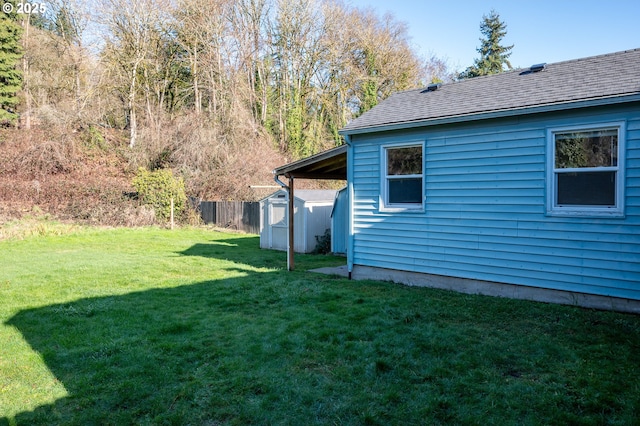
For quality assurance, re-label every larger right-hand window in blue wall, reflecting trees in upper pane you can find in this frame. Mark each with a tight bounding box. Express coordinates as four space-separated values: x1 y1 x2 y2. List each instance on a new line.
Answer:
548 123 624 216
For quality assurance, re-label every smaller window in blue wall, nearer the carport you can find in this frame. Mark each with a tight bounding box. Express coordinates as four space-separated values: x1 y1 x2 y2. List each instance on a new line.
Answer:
382 144 424 210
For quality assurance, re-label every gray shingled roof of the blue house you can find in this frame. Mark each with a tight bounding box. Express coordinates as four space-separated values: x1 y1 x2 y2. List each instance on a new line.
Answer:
340 49 640 134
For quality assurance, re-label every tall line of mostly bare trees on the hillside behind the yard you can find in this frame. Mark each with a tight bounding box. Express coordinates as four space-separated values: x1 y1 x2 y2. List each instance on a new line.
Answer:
0 0 504 201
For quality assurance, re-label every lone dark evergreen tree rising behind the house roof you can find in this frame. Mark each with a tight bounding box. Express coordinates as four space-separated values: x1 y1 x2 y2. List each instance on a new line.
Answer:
458 10 513 79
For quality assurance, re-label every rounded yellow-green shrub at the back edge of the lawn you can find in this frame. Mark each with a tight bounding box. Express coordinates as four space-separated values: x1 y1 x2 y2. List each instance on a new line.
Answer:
133 168 187 219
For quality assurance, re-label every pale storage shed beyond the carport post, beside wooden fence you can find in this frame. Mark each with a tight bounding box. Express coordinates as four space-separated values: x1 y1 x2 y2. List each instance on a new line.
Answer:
260 189 336 253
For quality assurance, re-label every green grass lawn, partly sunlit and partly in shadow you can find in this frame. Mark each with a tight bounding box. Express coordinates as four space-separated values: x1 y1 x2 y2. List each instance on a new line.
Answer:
0 229 640 425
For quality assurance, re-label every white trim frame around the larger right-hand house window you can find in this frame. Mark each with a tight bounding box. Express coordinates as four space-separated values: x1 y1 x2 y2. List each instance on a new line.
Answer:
546 121 626 217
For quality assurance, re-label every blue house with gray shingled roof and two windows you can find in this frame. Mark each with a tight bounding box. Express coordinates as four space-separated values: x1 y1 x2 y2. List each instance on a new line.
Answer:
338 49 640 312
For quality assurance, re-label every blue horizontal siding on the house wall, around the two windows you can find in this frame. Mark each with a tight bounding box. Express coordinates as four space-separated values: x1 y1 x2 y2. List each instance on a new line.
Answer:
353 108 640 299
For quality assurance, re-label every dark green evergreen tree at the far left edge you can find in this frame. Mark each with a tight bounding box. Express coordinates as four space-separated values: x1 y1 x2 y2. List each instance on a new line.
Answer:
0 6 22 123
